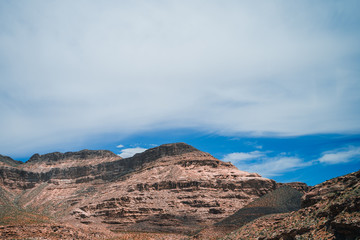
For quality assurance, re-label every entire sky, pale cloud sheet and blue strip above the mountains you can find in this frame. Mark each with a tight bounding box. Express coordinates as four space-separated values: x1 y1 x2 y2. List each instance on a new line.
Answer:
0 0 360 185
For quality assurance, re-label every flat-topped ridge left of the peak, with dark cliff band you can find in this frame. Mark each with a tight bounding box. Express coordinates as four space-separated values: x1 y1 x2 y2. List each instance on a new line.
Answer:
0 150 127 190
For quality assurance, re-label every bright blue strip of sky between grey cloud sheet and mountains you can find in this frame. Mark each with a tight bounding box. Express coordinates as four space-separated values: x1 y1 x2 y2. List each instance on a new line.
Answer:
0 133 360 186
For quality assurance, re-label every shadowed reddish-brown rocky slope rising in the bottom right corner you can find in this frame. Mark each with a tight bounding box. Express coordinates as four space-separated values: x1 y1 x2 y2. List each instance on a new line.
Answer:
223 171 360 240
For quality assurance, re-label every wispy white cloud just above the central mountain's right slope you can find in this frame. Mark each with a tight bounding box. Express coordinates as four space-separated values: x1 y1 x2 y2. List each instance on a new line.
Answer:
222 151 312 177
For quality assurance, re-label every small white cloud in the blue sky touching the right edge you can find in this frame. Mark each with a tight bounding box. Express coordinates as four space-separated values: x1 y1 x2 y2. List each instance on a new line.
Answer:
319 146 360 164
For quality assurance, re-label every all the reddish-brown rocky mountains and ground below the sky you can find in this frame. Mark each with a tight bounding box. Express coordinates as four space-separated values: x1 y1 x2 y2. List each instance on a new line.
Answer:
0 143 360 240
